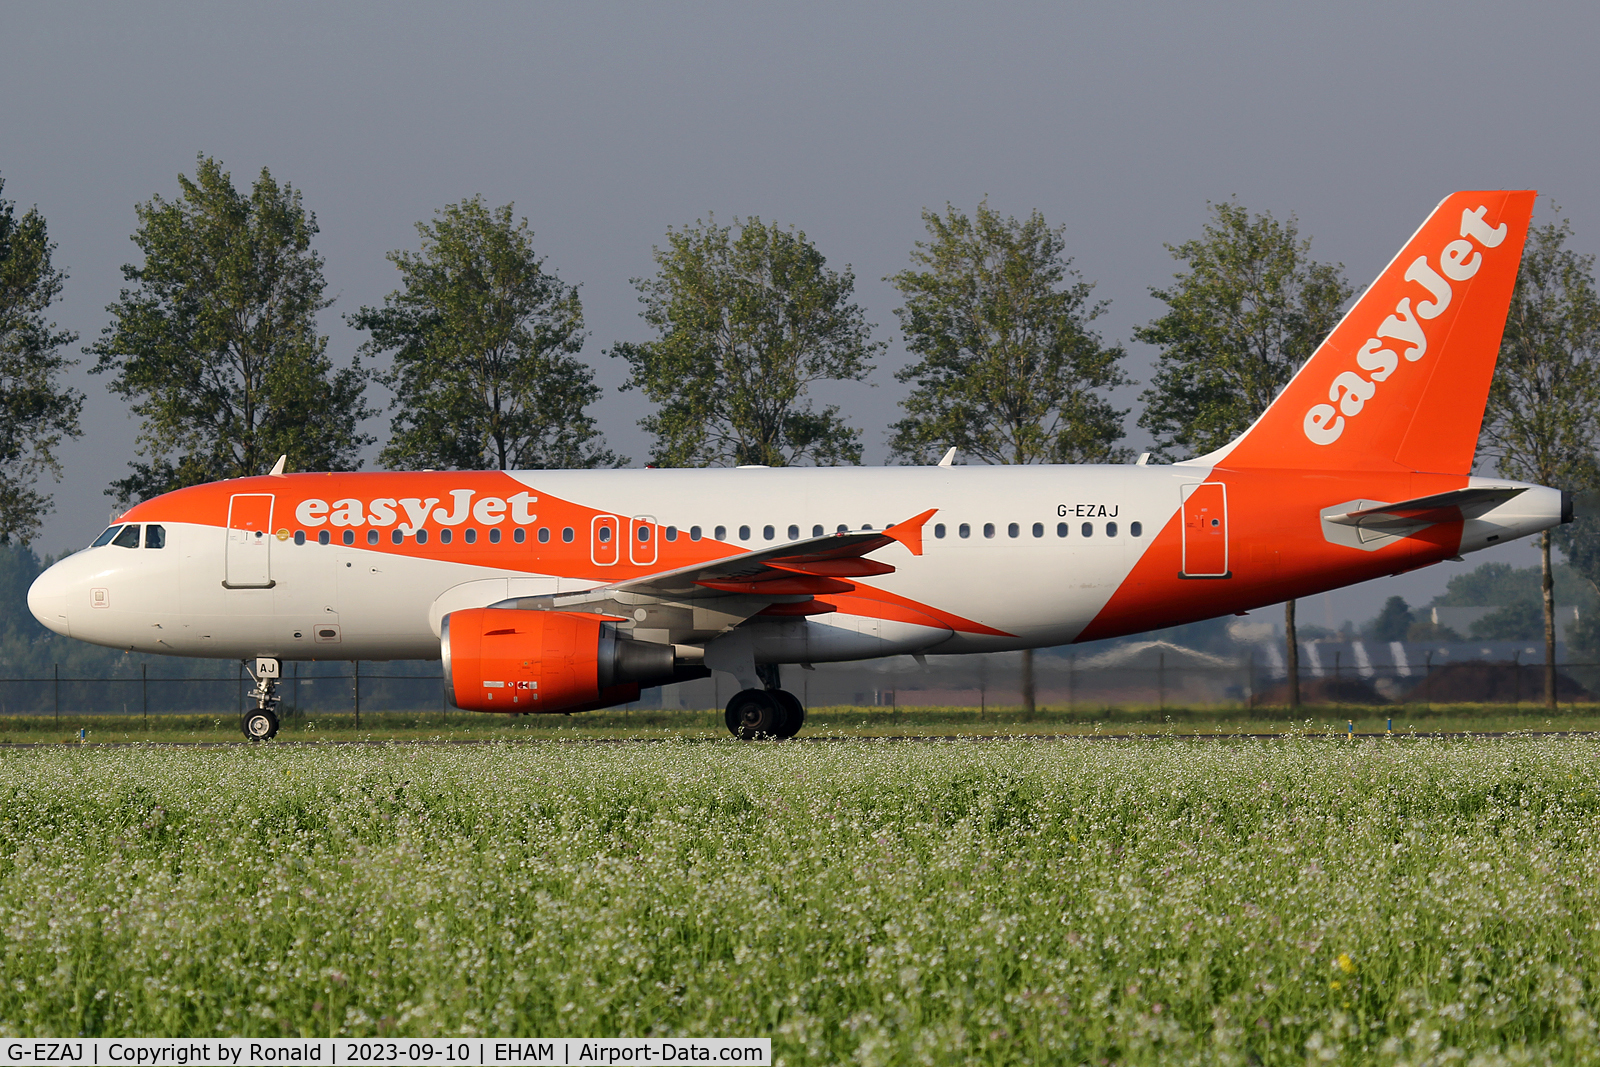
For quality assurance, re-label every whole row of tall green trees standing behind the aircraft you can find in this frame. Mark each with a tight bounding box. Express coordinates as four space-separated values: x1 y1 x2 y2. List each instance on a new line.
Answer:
0 155 1600 710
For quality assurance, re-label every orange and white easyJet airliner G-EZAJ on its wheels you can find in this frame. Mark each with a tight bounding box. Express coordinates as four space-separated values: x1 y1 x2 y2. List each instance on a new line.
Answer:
29 190 1571 739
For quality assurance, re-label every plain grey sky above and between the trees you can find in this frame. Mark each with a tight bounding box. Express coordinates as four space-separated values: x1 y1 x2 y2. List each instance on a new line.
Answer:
0 2 1600 622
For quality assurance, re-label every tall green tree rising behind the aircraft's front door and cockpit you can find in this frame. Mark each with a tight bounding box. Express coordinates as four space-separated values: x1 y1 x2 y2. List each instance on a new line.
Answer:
88 155 373 502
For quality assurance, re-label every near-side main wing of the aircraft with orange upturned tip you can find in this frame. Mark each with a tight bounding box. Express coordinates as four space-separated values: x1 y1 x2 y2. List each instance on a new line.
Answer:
493 509 938 643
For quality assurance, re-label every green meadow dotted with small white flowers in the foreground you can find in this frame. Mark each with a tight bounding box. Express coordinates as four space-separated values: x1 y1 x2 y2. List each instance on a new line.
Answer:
0 737 1600 1064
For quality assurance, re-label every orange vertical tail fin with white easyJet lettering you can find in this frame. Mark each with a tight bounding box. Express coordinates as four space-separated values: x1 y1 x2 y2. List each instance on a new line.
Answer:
1194 190 1534 474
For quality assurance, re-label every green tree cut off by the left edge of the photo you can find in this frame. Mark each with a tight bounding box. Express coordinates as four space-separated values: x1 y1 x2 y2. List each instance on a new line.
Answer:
0 179 83 544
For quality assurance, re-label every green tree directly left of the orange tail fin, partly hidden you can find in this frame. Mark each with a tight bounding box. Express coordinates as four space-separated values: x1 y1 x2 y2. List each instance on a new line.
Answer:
1133 203 1354 705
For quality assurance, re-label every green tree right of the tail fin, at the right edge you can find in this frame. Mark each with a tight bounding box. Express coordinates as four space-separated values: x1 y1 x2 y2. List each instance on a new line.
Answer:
1478 211 1600 710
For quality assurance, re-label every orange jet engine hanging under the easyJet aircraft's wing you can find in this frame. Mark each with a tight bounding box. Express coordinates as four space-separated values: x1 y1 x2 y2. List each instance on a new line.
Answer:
440 608 675 712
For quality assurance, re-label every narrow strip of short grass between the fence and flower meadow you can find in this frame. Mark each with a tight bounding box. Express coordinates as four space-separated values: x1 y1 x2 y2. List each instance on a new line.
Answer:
0 704 1600 745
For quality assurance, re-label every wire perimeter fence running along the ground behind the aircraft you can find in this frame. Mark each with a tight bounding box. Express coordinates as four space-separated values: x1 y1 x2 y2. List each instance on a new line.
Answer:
0 653 1600 720
